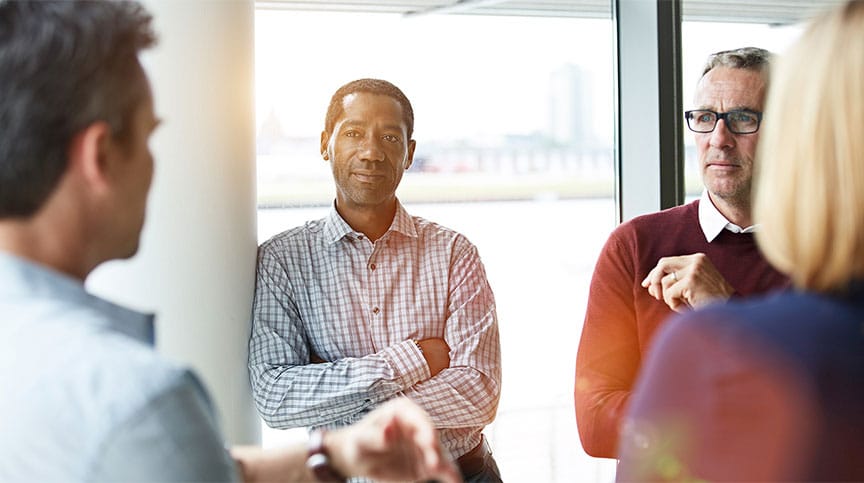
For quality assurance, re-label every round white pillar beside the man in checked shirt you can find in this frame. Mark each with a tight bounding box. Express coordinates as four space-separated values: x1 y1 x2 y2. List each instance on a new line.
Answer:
88 0 260 444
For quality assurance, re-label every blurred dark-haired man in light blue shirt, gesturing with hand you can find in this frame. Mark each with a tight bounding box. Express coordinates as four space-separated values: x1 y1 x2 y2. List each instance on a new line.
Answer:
0 1 458 482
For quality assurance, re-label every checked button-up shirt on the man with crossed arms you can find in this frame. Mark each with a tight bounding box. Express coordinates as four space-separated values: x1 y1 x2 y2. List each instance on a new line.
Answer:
249 200 501 457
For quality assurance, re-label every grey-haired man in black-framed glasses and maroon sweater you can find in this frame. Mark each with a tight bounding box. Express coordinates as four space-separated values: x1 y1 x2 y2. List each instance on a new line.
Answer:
574 47 788 458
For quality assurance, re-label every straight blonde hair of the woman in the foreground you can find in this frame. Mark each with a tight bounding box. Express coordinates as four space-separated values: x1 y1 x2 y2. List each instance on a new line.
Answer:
753 0 864 292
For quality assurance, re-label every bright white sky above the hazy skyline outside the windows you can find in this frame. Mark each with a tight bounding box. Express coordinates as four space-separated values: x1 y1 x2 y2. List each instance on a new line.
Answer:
255 10 800 144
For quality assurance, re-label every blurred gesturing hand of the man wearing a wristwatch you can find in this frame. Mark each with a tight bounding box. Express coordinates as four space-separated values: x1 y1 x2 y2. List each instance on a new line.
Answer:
324 398 462 483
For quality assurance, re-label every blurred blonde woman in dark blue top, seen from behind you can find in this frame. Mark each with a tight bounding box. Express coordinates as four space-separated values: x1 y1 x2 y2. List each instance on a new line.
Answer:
618 0 864 481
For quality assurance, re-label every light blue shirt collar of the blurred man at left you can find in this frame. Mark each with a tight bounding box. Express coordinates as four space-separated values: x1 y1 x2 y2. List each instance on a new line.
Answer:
0 252 155 346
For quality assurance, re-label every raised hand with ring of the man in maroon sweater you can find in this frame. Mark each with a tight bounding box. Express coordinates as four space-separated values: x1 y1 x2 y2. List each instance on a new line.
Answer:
642 253 735 312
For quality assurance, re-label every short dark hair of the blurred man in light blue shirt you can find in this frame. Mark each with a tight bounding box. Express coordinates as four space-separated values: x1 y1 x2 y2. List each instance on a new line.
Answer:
0 0 156 218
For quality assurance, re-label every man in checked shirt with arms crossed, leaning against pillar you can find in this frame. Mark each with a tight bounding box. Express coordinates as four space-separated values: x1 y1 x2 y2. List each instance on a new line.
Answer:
249 79 501 481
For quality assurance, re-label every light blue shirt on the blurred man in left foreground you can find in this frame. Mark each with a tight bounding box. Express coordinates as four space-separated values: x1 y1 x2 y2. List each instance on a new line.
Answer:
0 253 237 482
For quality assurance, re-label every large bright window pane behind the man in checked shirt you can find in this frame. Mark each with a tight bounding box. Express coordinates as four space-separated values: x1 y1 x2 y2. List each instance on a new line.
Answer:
256 6 615 482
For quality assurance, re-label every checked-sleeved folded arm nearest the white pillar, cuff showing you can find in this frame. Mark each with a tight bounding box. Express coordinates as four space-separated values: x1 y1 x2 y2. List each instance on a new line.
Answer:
249 253 429 428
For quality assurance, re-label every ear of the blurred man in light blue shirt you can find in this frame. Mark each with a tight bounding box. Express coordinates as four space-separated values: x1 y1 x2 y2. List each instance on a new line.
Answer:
67 121 111 194
